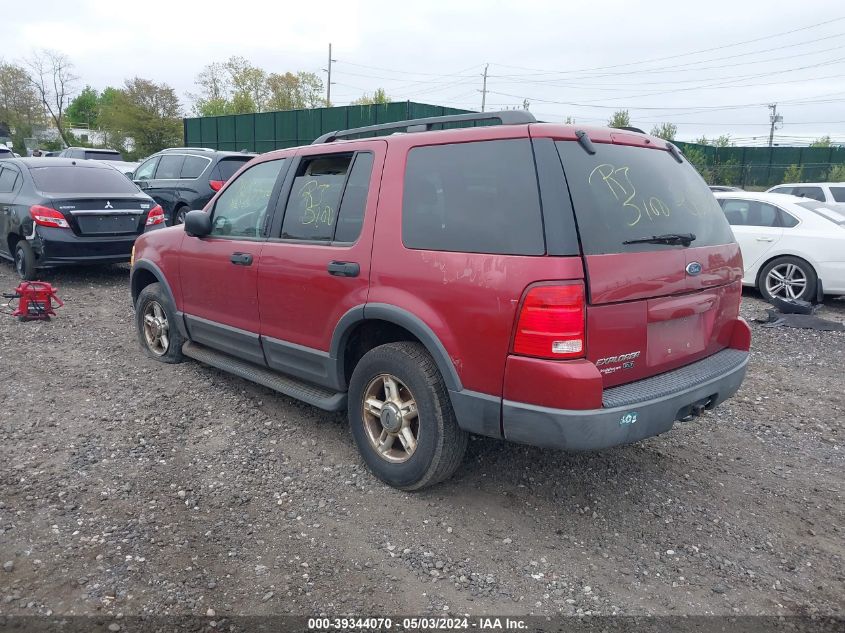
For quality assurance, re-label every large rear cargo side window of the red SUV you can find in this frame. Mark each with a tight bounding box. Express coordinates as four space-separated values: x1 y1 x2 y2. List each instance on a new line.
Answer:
402 139 545 255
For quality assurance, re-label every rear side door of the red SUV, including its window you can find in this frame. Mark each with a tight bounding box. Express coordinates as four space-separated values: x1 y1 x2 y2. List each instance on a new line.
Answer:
258 140 387 382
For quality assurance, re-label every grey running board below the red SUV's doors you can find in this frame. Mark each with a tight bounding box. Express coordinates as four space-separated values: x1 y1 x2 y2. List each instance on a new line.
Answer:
182 341 346 411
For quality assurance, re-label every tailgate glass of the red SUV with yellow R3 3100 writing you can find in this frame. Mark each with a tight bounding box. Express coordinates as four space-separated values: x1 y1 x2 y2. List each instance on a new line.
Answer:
557 141 734 255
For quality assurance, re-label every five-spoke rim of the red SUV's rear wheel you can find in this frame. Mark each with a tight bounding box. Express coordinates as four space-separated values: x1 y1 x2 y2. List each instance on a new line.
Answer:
362 374 420 464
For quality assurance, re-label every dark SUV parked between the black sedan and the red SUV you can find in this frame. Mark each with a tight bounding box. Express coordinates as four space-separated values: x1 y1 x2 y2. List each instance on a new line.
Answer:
132 147 255 225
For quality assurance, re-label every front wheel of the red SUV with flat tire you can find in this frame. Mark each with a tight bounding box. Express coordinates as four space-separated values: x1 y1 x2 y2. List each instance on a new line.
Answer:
135 283 185 363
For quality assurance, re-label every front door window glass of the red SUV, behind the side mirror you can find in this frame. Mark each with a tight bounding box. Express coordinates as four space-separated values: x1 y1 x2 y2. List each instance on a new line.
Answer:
211 158 287 237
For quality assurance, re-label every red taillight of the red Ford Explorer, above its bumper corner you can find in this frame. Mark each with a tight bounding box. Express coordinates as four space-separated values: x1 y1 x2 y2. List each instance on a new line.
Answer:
513 282 585 359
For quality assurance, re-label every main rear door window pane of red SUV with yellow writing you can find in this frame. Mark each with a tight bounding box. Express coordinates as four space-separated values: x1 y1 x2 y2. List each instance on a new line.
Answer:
282 154 353 242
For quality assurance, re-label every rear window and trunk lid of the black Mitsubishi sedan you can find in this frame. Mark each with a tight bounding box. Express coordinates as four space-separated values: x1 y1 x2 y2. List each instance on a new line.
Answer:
30 161 154 237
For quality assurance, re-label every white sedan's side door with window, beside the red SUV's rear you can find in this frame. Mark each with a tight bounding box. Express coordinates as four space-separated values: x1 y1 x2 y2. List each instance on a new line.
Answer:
719 198 783 273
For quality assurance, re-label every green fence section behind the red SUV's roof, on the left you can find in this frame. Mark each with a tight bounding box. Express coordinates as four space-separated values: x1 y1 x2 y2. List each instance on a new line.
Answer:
184 101 470 152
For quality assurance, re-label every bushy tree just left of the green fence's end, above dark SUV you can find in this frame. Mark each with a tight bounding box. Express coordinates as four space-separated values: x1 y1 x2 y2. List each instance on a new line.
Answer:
100 77 182 156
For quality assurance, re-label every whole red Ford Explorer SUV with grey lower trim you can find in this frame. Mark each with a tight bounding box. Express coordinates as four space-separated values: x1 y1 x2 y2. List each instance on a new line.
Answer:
131 112 750 490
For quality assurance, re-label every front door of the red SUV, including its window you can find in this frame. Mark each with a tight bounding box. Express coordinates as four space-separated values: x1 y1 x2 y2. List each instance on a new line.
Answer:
179 158 288 364
